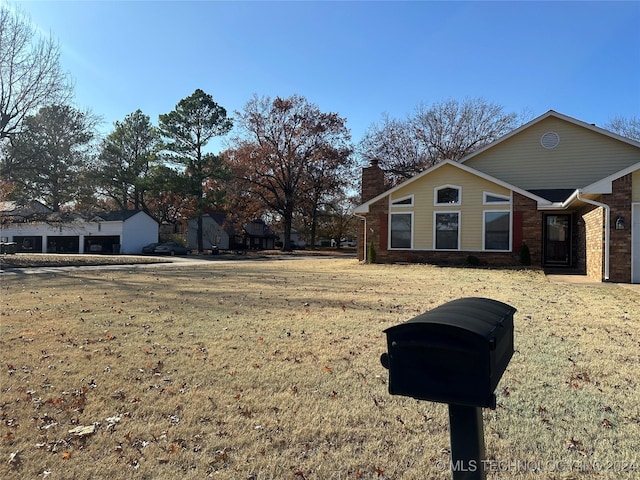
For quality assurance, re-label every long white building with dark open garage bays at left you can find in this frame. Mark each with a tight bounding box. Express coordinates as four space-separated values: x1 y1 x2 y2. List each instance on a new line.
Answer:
0 202 158 254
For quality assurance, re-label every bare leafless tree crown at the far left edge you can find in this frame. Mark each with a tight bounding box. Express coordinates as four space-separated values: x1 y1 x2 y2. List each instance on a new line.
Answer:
0 4 72 141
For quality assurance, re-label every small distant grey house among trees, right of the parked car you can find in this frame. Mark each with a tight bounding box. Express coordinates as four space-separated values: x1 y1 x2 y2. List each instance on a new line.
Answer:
187 213 276 250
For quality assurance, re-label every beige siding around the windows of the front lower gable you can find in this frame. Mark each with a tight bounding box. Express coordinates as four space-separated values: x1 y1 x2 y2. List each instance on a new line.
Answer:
390 165 511 251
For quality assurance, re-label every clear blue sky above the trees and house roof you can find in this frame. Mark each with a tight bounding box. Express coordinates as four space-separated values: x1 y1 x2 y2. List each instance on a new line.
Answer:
12 0 640 154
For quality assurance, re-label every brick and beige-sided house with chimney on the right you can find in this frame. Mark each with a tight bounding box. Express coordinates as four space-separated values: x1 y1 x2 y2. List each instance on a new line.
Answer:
355 110 640 283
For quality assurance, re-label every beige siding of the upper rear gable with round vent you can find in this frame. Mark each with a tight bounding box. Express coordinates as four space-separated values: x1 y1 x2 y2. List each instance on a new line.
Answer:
465 117 640 190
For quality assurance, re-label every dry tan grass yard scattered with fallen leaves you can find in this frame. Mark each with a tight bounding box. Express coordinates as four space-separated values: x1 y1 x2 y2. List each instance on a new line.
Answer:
0 258 640 480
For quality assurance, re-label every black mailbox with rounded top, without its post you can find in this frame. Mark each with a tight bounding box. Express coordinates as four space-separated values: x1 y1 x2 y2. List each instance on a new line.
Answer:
381 298 516 408
